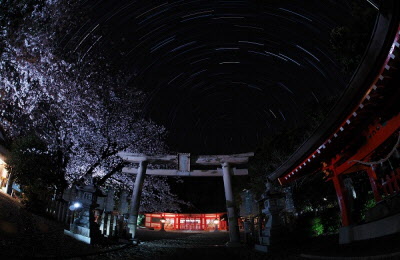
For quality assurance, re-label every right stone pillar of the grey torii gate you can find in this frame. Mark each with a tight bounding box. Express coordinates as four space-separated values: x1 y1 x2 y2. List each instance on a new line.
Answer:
222 162 240 246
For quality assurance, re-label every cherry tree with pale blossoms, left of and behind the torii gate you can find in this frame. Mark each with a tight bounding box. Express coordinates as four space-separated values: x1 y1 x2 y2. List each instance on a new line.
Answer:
0 0 188 210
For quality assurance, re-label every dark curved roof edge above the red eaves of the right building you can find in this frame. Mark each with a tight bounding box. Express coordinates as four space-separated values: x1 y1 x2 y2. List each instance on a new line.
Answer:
268 0 400 181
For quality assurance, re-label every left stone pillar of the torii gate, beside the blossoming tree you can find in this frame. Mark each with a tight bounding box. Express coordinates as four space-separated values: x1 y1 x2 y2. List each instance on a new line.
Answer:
128 161 147 239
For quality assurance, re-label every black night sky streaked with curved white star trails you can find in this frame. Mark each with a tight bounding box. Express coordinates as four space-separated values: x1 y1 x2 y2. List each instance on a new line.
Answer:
64 0 374 209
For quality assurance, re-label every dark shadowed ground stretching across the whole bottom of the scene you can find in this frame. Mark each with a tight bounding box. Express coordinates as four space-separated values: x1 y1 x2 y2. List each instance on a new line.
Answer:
0 193 400 260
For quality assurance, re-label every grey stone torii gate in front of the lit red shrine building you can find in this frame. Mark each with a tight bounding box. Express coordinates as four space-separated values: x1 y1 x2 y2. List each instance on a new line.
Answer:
118 152 254 246
